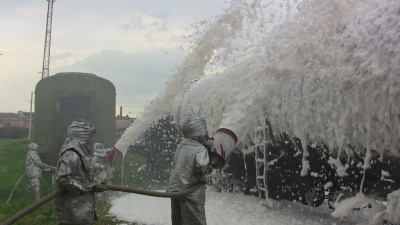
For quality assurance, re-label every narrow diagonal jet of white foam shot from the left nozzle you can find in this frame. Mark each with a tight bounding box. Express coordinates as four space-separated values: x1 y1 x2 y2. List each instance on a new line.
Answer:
115 1 272 154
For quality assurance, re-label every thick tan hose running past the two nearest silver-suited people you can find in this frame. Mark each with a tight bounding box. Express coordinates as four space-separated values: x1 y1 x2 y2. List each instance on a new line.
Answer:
1 183 202 225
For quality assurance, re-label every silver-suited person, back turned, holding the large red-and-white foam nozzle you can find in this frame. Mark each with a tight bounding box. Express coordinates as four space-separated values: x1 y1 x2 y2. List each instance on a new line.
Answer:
167 117 211 225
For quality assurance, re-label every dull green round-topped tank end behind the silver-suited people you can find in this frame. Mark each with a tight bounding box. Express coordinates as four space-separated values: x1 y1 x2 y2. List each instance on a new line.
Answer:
33 72 116 165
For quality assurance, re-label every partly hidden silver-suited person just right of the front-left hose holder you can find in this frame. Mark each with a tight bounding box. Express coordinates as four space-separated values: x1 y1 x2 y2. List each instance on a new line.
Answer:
93 143 113 184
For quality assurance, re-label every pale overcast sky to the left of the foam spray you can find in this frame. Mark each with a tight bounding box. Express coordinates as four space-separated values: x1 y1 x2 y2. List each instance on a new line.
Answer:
0 0 225 117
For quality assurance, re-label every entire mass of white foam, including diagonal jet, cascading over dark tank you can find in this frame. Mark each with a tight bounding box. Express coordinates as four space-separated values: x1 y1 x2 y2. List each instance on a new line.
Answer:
116 0 400 220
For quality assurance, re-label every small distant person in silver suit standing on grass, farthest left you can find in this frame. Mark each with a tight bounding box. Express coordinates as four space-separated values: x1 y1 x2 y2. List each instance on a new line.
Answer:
25 143 51 201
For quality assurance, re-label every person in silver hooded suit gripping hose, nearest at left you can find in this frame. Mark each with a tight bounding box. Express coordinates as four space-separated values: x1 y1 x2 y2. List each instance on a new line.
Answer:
54 120 95 224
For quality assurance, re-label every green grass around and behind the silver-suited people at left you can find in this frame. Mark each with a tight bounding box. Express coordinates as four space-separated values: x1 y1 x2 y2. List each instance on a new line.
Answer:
0 139 161 225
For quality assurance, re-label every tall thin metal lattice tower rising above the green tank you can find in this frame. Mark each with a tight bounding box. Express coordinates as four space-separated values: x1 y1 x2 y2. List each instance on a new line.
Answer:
42 0 56 79
